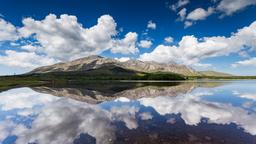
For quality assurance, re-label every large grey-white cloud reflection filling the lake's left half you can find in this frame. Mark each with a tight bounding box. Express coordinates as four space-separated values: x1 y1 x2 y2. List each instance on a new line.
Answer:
0 88 141 144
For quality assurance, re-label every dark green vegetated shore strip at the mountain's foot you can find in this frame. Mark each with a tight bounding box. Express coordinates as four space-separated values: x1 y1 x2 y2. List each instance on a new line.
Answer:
0 69 185 91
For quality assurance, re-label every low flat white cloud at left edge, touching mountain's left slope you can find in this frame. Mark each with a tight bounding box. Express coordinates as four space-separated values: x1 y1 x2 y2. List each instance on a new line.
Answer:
0 50 59 69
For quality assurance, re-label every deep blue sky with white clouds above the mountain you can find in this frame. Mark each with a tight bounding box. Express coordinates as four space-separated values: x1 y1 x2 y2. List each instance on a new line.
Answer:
0 0 256 75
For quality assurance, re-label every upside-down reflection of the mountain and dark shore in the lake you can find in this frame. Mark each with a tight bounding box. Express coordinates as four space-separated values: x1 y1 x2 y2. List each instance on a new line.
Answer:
32 82 224 104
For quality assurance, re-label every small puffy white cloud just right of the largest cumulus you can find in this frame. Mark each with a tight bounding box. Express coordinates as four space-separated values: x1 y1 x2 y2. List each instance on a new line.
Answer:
111 32 139 54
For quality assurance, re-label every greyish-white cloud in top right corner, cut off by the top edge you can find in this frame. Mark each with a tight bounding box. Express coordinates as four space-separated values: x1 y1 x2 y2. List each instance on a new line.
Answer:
217 0 256 15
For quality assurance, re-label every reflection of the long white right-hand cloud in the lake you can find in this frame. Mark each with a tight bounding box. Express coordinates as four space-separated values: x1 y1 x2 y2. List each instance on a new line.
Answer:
138 92 256 135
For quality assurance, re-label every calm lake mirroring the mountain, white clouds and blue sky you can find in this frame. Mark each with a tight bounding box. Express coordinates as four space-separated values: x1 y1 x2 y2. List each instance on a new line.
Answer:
0 80 256 144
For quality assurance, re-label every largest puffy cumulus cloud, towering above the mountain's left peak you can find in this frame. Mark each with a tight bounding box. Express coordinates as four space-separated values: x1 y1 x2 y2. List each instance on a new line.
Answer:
19 14 117 60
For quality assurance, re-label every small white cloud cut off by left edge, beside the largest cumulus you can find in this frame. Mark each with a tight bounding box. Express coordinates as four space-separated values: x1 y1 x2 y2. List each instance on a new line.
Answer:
0 18 18 41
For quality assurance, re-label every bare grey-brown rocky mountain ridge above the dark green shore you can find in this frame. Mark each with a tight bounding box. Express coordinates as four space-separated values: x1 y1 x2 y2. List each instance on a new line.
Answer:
29 55 199 76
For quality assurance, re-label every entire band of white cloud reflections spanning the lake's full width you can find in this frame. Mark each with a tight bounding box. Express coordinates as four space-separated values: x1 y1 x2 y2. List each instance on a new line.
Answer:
0 81 256 144
